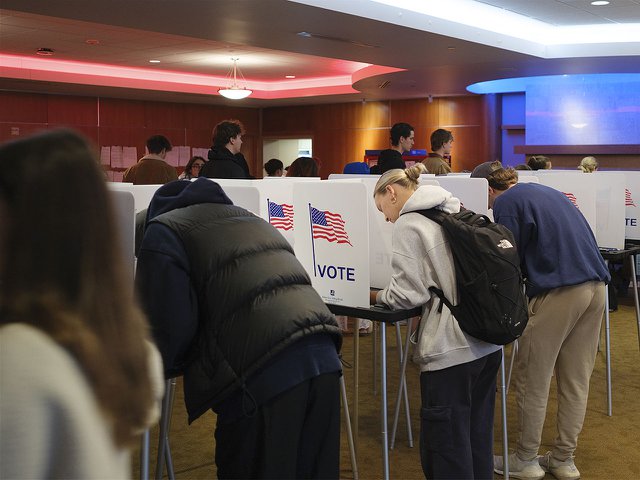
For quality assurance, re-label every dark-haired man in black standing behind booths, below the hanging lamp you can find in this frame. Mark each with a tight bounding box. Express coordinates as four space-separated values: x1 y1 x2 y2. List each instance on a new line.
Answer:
200 120 254 178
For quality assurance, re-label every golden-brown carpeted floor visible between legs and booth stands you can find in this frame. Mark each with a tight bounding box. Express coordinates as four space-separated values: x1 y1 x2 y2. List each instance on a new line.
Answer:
133 301 640 480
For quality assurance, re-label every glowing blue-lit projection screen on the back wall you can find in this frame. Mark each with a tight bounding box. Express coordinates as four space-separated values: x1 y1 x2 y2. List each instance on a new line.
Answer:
526 78 640 145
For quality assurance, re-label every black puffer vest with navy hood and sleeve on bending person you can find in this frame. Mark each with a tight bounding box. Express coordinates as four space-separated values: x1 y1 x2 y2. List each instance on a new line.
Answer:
137 179 341 421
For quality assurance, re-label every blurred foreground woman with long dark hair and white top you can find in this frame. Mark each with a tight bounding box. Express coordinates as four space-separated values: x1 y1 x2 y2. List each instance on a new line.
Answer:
0 130 162 478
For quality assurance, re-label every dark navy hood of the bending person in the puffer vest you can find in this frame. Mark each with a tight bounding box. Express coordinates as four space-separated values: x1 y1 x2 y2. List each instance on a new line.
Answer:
147 178 233 222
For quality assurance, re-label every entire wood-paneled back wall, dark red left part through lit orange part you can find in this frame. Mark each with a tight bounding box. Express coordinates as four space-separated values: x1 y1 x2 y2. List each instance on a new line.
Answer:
0 92 490 178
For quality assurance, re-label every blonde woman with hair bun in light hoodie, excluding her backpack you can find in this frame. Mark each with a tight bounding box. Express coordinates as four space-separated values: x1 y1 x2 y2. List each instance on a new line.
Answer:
371 164 502 479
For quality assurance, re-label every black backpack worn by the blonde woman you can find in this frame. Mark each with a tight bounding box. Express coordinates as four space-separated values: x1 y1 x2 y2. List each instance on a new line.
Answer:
408 209 529 345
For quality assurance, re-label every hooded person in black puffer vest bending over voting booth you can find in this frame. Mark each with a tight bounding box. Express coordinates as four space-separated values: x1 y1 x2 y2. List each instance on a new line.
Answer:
136 178 342 478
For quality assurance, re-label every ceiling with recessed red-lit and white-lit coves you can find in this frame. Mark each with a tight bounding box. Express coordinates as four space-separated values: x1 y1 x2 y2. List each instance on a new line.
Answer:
0 0 640 107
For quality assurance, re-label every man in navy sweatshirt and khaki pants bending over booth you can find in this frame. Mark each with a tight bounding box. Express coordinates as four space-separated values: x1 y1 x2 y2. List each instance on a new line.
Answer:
472 162 610 480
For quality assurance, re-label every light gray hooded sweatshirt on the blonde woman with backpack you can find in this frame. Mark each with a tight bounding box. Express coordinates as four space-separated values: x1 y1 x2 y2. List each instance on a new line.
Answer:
377 185 500 372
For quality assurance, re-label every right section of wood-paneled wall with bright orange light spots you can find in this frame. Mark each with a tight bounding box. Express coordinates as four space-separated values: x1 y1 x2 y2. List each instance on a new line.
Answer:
262 96 491 177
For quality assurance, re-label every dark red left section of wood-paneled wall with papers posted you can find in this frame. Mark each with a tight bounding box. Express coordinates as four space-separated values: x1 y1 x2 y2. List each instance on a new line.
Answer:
0 92 262 176
